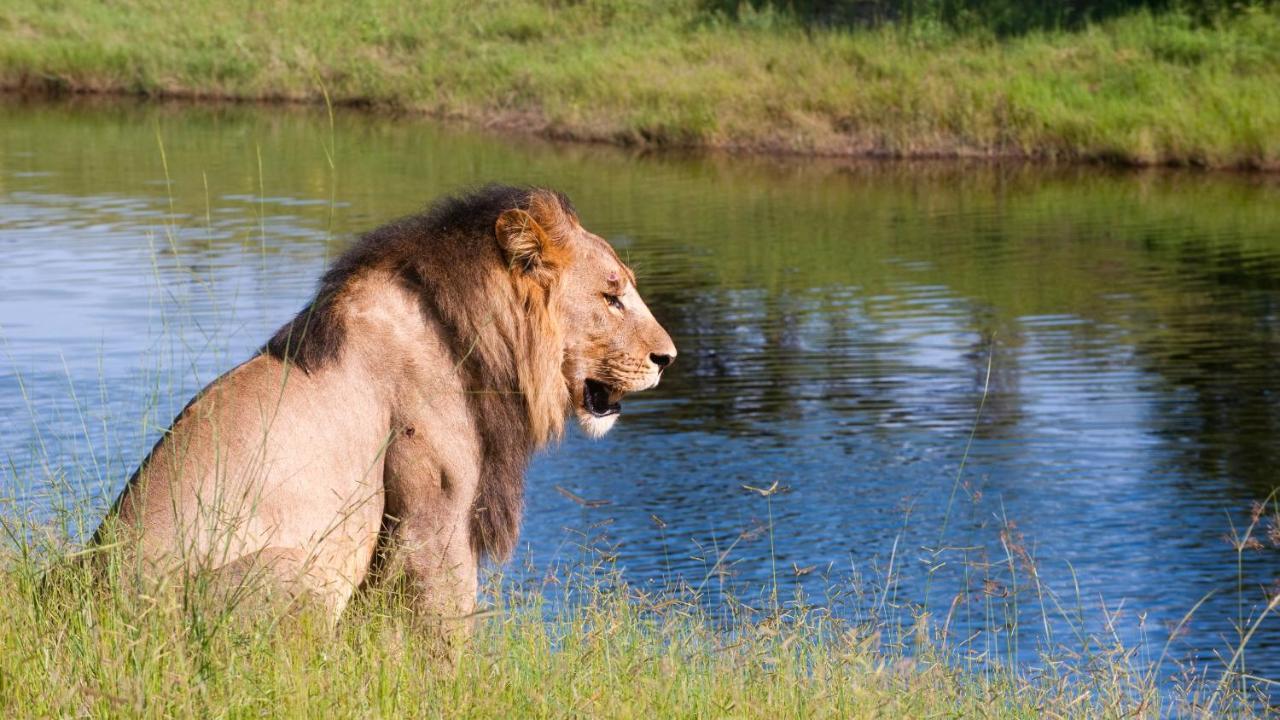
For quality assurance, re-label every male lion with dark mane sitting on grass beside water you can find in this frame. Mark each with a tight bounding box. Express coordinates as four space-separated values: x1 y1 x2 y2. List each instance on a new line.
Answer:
95 186 676 627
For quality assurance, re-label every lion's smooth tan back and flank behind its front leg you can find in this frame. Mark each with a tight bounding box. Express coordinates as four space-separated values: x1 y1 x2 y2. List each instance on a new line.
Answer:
106 355 383 565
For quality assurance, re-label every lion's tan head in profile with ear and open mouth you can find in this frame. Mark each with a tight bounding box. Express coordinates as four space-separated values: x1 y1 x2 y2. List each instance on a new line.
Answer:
495 191 676 437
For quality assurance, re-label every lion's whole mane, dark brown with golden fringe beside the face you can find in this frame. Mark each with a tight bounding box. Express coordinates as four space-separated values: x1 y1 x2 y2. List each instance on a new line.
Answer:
262 184 576 560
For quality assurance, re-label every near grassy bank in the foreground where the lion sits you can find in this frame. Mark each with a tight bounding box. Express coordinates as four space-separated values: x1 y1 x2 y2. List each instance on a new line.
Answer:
0 535 1261 719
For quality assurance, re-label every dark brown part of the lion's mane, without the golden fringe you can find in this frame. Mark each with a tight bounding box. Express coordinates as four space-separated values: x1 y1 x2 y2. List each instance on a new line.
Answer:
262 184 576 559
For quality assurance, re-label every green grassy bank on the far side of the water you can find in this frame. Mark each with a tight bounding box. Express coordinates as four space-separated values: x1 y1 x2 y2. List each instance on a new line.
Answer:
0 0 1280 169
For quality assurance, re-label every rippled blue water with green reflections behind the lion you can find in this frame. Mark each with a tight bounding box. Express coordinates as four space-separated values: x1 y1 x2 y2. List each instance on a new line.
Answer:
0 101 1280 678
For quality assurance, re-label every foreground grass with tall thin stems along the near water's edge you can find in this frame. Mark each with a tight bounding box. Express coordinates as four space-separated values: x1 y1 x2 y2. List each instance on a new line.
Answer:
0 476 1280 720
